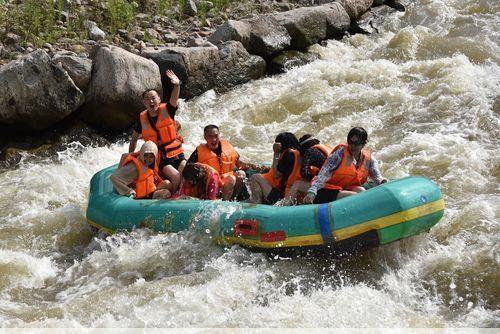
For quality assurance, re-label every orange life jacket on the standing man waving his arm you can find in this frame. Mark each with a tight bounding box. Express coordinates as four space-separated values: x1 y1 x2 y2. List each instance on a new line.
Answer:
139 103 184 158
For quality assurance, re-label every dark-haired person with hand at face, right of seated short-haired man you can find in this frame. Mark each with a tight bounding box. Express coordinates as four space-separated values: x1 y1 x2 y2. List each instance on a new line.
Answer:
250 132 301 205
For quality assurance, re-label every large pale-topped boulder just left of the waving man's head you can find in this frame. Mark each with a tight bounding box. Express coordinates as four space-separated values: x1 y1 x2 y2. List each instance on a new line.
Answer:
82 46 162 131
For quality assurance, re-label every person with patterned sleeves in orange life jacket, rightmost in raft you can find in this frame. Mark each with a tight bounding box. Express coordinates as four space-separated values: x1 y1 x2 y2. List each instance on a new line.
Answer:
304 127 387 204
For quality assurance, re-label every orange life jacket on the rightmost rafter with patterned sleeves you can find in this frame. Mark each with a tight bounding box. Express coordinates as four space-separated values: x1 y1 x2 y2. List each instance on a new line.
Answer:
324 144 371 190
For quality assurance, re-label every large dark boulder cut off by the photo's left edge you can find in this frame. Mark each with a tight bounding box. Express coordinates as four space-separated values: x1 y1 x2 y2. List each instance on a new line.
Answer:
0 49 85 131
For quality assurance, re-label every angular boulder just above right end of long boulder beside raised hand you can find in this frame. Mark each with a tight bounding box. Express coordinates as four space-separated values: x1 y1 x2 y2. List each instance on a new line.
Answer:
242 16 291 58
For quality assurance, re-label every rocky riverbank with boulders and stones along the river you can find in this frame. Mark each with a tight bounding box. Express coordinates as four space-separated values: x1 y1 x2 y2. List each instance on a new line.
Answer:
0 0 402 167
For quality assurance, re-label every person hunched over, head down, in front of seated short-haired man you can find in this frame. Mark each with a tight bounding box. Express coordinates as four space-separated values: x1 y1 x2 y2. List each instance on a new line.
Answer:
179 162 222 200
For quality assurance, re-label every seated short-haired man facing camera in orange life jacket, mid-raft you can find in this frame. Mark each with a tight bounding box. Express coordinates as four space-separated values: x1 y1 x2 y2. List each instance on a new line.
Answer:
188 124 260 201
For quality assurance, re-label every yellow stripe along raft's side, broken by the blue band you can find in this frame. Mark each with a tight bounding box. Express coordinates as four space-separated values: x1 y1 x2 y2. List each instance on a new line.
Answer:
214 199 444 248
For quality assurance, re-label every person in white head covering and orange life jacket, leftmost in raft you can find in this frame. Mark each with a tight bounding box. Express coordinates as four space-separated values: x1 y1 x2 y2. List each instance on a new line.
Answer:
109 141 171 199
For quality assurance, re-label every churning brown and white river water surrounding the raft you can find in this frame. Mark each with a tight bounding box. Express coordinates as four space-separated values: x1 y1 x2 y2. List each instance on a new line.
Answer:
0 0 500 327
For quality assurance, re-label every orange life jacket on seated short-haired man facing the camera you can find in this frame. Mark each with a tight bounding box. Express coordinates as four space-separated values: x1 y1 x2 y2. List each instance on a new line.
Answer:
196 139 239 175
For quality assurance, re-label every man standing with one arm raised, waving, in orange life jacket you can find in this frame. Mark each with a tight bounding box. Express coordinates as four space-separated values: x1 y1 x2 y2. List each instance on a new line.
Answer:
128 70 186 191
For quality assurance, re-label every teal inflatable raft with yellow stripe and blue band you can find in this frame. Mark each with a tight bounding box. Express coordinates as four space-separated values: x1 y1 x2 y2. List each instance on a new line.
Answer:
87 165 444 250
